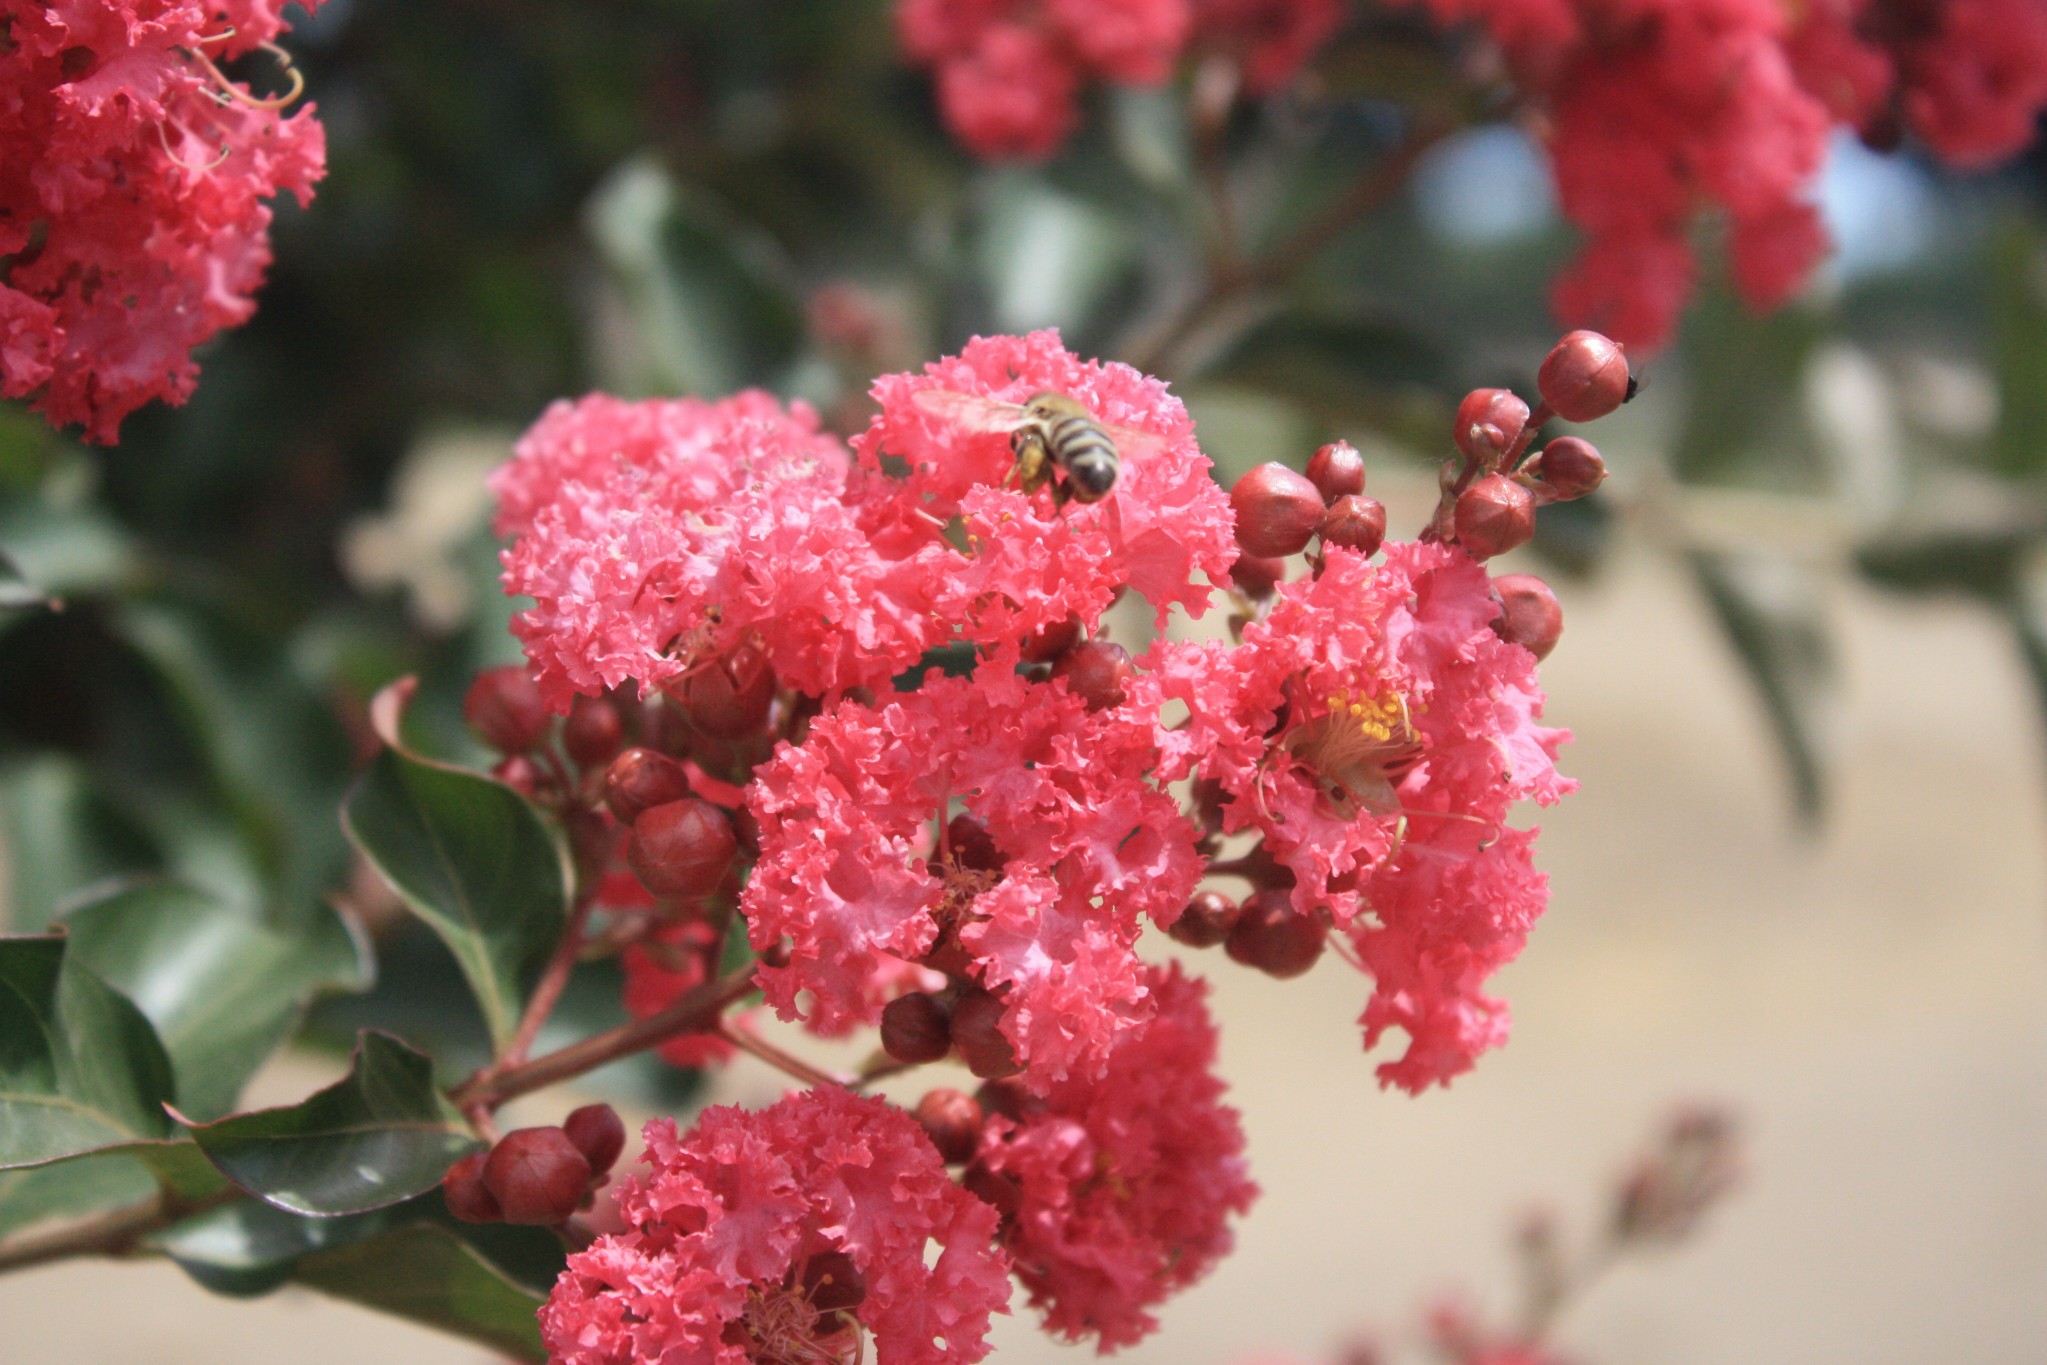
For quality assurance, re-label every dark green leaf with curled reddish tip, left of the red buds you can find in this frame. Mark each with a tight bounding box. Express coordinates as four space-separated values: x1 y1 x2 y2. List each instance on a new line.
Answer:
342 749 569 1042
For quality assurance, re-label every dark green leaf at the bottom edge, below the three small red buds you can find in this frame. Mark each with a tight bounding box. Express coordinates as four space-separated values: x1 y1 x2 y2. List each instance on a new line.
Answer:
293 1224 547 1361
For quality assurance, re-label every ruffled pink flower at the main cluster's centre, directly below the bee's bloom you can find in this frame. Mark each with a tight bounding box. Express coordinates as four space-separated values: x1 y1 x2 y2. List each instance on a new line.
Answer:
741 665 1200 1085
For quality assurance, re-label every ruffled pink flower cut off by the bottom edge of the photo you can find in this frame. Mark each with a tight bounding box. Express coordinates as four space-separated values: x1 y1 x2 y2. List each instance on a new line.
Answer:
540 1087 1009 1365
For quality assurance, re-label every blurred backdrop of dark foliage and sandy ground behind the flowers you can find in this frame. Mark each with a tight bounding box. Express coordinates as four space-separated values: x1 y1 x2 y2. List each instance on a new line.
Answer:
0 0 2047 1365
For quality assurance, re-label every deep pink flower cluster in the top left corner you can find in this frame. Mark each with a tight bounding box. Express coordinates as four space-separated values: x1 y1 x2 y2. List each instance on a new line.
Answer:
0 0 325 444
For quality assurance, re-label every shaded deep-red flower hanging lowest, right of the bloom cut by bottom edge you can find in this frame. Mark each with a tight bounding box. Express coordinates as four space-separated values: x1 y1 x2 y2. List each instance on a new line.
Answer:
968 964 1257 1351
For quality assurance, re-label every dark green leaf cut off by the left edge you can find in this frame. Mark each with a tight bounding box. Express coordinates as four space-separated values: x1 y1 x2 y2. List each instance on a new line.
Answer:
0 937 172 1169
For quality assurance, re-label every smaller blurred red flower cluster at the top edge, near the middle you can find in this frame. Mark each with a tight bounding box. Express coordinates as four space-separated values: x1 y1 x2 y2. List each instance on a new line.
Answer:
897 0 1343 160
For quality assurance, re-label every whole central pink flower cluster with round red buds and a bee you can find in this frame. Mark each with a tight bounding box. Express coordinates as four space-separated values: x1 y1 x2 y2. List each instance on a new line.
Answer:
487 334 1588 1365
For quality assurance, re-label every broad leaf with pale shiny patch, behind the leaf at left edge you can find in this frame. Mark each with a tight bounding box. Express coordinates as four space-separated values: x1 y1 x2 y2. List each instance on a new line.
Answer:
63 882 371 1119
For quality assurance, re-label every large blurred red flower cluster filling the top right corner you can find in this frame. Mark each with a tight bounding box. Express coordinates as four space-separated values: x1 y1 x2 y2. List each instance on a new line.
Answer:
1417 0 2047 346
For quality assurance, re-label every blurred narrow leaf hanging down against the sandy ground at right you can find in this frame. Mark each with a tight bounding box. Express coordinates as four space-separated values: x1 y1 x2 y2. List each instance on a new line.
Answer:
1691 555 1834 823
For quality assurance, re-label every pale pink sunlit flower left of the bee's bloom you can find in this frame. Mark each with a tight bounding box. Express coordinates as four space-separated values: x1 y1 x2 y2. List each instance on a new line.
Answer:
491 384 935 710
